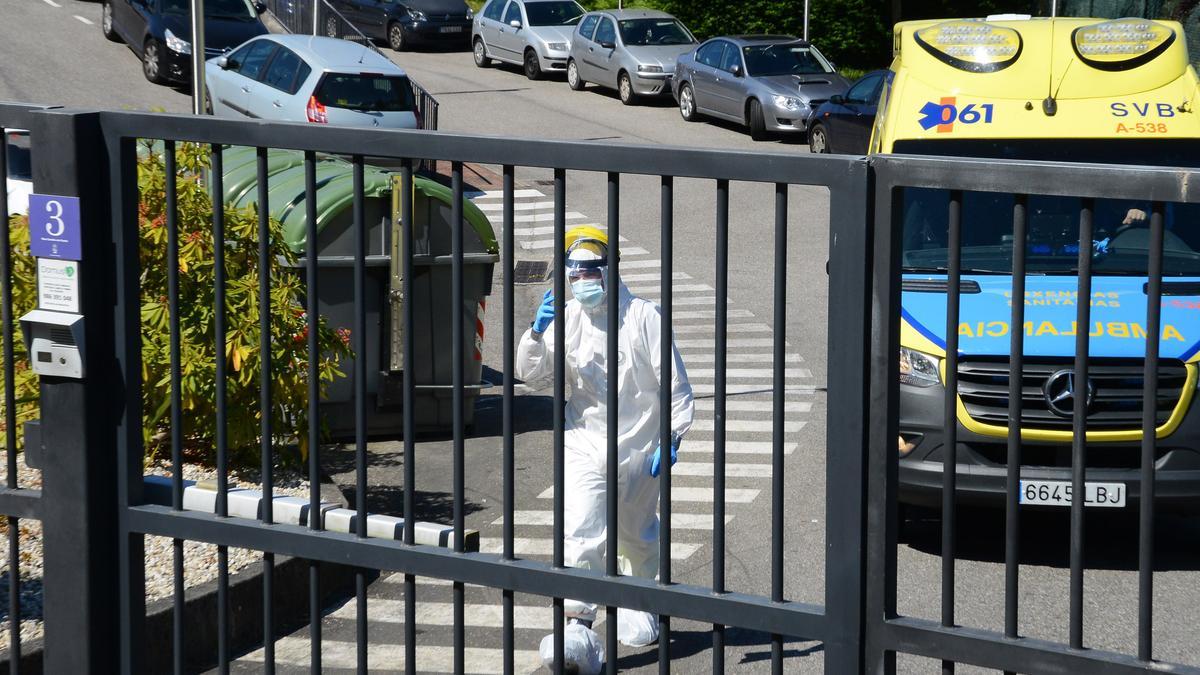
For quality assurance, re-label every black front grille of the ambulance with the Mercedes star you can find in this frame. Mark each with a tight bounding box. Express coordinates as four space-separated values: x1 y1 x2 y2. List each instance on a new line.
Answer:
959 357 1188 431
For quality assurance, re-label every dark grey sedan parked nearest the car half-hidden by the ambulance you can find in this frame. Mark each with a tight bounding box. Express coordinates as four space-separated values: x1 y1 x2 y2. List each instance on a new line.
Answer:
673 35 848 141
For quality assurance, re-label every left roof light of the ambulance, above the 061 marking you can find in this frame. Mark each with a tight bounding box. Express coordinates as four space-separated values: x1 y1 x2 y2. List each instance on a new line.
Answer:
912 20 1022 72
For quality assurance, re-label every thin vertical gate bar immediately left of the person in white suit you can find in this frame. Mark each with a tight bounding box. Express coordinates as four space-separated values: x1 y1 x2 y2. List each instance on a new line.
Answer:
503 165 517 675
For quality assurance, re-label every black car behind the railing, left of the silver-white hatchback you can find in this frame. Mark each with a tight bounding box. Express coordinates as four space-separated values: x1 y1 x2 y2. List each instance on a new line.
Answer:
325 0 474 52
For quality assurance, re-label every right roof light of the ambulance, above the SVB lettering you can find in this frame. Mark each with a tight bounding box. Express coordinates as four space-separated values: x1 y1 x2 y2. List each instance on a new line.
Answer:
1072 19 1175 71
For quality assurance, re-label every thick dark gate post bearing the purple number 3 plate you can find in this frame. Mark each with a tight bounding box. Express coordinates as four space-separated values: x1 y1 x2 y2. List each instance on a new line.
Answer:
30 110 124 674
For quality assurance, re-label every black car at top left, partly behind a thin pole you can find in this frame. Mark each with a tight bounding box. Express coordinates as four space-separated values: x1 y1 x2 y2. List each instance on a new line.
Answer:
100 0 268 84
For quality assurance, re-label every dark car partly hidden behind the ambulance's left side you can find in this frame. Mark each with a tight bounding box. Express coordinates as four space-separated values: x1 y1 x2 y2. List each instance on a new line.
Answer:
809 70 892 155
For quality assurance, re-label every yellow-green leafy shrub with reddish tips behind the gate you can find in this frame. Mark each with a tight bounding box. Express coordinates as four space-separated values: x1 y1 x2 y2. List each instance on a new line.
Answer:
0 144 350 465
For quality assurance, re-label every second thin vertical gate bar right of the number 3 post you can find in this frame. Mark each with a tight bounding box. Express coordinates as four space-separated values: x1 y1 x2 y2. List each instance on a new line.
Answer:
212 144 229 675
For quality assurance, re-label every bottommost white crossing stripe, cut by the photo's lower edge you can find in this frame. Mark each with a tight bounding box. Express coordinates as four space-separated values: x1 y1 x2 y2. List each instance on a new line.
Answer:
238 635 541 674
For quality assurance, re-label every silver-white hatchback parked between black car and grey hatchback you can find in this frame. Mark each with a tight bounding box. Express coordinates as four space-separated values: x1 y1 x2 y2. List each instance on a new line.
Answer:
470 0 584 79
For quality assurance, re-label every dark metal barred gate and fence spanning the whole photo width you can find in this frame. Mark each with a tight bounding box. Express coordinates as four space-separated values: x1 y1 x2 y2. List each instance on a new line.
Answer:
0 102 1200 673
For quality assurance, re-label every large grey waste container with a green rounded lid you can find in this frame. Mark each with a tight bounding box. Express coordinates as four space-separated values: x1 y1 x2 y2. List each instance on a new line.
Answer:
224 148 499 437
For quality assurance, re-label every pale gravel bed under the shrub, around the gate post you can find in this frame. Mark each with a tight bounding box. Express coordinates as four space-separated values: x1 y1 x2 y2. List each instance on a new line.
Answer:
0 454 308 657
